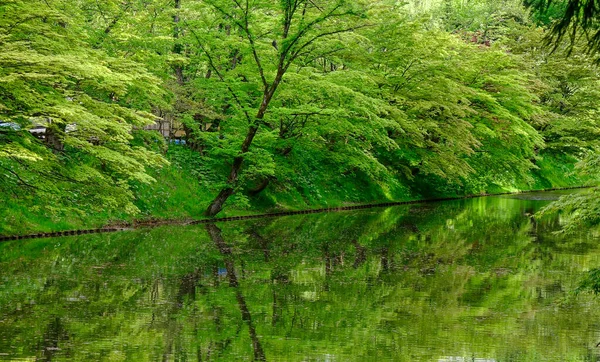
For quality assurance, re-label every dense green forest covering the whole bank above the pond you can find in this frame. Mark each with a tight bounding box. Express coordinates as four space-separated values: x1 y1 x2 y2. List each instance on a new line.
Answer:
0 0 600 235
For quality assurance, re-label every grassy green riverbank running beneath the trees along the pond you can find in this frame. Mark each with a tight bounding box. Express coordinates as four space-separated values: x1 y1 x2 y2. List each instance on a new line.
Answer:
0 147 586 237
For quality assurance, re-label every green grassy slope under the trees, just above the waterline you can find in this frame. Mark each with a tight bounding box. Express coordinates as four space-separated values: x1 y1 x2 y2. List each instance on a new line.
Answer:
0 148 585 235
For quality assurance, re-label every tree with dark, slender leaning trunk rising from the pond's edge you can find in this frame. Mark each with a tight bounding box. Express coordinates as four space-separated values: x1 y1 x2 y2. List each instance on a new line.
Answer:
180 0 361 216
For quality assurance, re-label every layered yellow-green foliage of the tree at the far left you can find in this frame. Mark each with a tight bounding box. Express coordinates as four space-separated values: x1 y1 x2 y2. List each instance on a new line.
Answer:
0 1 164 221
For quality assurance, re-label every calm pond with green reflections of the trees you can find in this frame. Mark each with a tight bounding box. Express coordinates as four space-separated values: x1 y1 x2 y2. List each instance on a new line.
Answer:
0 193 600 362
